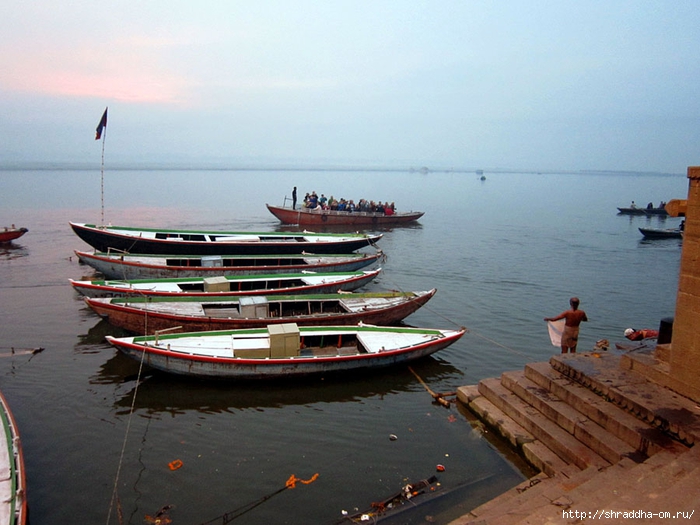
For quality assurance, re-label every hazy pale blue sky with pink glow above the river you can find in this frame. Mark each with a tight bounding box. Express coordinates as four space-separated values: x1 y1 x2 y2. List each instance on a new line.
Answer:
0 0 700 173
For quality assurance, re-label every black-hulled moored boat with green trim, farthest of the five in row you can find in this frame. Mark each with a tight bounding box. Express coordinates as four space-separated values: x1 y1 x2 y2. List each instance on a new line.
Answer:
70 222 382 255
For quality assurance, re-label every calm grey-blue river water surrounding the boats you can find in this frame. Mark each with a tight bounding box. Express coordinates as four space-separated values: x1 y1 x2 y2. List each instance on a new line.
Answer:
0 169 688 525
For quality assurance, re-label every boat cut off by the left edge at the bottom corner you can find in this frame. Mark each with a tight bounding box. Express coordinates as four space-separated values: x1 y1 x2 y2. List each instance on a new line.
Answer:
0 392 27 525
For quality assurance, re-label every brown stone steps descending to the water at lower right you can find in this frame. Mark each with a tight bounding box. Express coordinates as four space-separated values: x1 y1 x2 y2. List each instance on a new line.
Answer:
451 354 700 525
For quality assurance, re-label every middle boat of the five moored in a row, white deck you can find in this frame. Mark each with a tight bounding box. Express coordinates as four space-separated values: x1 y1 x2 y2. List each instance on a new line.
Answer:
70 268 381 297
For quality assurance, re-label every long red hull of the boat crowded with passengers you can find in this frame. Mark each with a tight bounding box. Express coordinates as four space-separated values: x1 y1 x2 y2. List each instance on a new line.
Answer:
266 204 425 226
